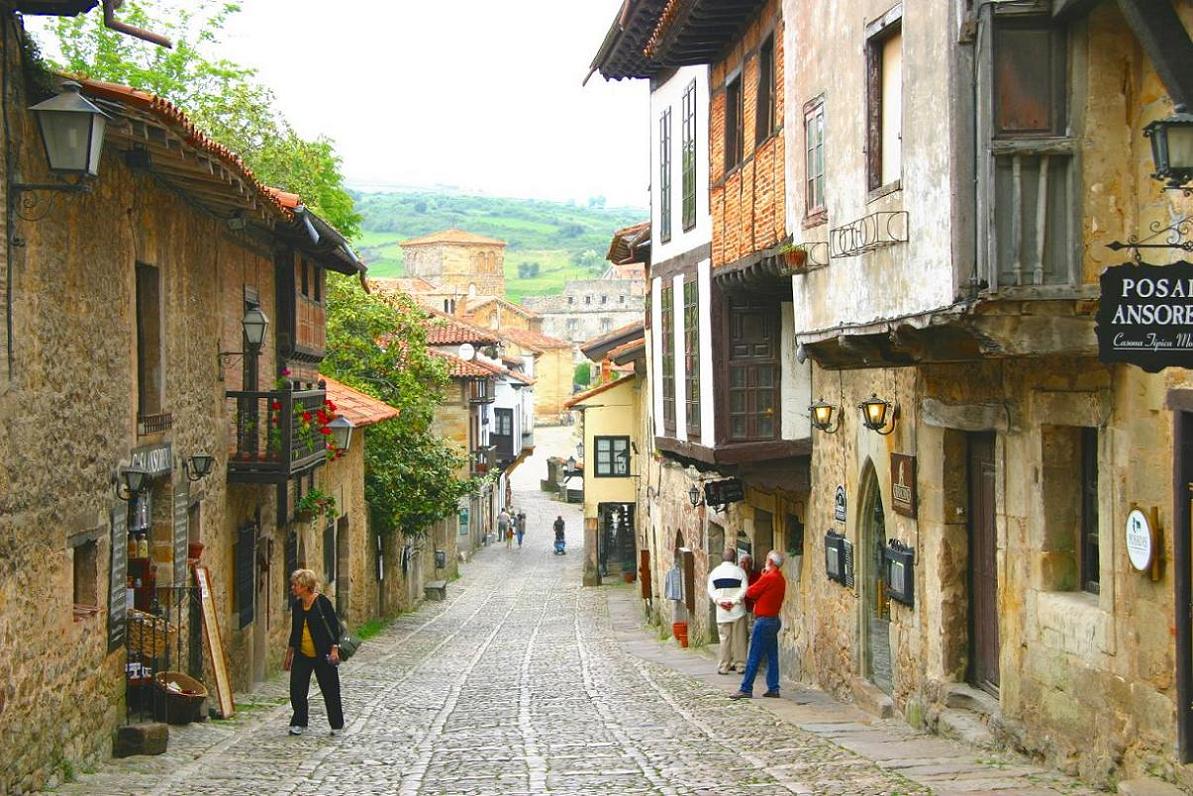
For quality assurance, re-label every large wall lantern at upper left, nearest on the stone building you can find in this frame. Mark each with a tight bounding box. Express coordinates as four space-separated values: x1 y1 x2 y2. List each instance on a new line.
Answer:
29 80 107 177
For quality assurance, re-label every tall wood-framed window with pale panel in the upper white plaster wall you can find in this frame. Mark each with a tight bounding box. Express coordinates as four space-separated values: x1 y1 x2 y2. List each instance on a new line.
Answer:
866 10 903 192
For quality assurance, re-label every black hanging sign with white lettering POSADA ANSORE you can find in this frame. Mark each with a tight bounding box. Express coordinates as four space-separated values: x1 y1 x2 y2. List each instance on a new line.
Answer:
1096 261 1193 374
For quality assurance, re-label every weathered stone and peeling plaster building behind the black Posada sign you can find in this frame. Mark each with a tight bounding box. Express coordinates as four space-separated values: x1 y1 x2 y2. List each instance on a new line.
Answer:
783 0 1193 788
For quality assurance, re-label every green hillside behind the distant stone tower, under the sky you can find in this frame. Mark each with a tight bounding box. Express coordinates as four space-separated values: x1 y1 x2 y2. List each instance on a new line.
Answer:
356 191 648 301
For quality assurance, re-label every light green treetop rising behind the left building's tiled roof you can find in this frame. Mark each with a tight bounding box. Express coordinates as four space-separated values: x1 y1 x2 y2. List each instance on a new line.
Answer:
49 0 361 237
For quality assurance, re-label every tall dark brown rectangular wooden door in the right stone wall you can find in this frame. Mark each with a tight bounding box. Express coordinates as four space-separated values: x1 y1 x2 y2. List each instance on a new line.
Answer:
969 433 999 695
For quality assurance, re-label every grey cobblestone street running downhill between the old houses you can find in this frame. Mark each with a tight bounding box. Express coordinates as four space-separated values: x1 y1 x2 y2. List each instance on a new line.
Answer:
48 430 1097 796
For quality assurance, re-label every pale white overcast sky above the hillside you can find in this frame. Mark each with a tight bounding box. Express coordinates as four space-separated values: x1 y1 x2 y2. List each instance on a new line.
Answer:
214 0 649 208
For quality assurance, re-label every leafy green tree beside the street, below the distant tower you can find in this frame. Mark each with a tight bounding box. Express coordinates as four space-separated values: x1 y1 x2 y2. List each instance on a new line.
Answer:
321 277 477 536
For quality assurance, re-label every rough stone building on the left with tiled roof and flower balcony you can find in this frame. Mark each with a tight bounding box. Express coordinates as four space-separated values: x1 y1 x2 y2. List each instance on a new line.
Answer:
0 14 359 792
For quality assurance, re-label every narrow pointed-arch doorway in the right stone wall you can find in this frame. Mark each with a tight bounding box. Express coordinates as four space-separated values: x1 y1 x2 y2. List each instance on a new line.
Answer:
858 461 894 693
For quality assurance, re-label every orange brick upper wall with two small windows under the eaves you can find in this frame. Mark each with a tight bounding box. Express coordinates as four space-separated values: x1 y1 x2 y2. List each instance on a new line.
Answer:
709 0 786 267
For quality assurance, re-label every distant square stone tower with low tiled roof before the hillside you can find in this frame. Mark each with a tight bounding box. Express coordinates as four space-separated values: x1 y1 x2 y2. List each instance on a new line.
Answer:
400 229 506 298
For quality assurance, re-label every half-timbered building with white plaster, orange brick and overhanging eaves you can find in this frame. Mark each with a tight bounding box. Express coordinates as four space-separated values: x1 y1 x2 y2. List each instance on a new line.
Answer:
593 0 811 658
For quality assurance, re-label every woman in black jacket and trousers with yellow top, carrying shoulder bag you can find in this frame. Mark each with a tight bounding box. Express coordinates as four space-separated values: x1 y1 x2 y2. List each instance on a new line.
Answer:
282 569 344 735
